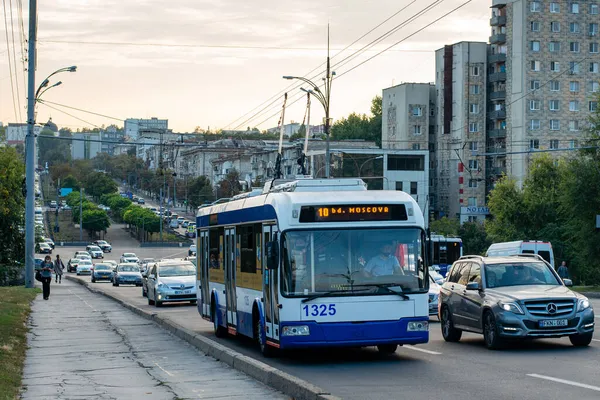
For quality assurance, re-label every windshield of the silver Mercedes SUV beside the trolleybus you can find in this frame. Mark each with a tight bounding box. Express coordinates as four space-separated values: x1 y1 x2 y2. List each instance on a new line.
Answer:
485 262 561 288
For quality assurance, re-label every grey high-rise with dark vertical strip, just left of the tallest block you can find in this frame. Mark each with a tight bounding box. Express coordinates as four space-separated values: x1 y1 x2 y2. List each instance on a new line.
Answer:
432 42 496 217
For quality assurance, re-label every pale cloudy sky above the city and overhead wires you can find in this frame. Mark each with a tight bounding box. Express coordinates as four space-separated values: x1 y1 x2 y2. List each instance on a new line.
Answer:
0 0 491 132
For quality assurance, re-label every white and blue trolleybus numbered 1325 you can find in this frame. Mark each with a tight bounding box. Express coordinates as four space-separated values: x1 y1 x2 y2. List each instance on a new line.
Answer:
196 179 429 356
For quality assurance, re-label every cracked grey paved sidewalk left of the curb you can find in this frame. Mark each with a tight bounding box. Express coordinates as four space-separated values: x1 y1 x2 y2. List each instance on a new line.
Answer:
22 280 287 400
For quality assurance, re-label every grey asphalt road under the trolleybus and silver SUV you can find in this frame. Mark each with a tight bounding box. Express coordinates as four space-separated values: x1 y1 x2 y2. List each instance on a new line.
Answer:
69 268 600 400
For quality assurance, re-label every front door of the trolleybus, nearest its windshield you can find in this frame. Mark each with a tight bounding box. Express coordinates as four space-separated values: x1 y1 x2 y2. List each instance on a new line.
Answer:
262 224 279 340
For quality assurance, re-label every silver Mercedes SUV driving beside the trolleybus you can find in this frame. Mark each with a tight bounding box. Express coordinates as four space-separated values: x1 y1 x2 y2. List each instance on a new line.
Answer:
439 254 594 349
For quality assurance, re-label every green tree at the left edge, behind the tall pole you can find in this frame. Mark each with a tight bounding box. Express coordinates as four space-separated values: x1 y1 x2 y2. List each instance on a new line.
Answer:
0 147 25 264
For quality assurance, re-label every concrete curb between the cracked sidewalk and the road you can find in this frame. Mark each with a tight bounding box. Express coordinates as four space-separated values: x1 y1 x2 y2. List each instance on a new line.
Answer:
65 275 341 400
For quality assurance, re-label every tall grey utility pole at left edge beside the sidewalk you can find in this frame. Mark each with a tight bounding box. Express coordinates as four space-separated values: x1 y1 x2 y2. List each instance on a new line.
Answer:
25 0 37 288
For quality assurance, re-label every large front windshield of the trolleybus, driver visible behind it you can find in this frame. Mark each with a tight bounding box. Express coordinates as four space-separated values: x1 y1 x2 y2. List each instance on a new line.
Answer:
281 229 428 296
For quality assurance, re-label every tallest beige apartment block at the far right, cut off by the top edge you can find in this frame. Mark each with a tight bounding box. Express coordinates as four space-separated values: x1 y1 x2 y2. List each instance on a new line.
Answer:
488 0 600 184
